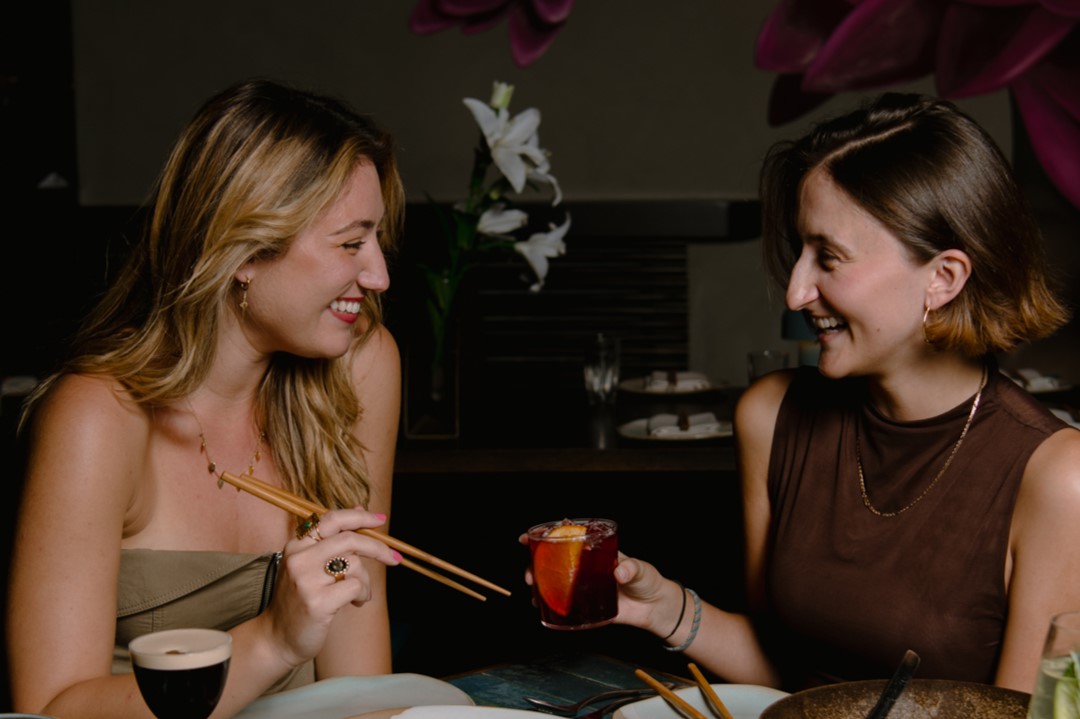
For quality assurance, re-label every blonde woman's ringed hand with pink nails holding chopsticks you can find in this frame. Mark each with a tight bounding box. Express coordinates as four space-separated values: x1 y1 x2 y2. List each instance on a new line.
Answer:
265 508 402 666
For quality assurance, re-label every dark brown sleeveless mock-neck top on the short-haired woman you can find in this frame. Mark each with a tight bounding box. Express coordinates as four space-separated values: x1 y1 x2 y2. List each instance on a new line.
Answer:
761 368 1068 688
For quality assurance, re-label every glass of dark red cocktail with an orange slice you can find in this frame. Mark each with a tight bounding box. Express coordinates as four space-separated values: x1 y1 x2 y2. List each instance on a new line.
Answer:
528 519 619 629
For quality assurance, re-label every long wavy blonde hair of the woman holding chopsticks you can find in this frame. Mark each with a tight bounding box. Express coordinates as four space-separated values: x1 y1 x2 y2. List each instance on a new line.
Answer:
24 80 404 507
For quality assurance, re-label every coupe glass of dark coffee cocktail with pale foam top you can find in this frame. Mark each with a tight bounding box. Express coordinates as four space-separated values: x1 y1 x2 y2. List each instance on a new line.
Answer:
127 628 232 719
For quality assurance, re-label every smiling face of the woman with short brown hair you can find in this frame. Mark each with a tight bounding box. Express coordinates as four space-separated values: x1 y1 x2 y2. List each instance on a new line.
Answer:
787 169 931 377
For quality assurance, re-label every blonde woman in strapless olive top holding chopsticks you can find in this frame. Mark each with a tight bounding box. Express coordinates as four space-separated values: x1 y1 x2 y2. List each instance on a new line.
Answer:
8 81 464 718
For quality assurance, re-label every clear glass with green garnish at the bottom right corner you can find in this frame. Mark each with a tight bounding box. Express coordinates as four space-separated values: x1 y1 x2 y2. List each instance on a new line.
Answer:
1027 611 1080 719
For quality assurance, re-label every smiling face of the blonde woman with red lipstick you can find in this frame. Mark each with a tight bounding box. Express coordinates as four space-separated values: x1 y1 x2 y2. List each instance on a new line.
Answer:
237 162 390 357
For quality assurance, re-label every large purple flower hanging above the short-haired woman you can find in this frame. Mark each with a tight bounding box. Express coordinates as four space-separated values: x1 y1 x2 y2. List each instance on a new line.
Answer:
755 0 1080 207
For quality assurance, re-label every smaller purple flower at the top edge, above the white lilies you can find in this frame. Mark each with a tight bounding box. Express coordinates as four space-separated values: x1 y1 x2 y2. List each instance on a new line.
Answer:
408 0 573 67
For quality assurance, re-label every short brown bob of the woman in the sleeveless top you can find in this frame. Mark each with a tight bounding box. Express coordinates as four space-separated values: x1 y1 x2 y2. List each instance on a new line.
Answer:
760 93 1068 357
